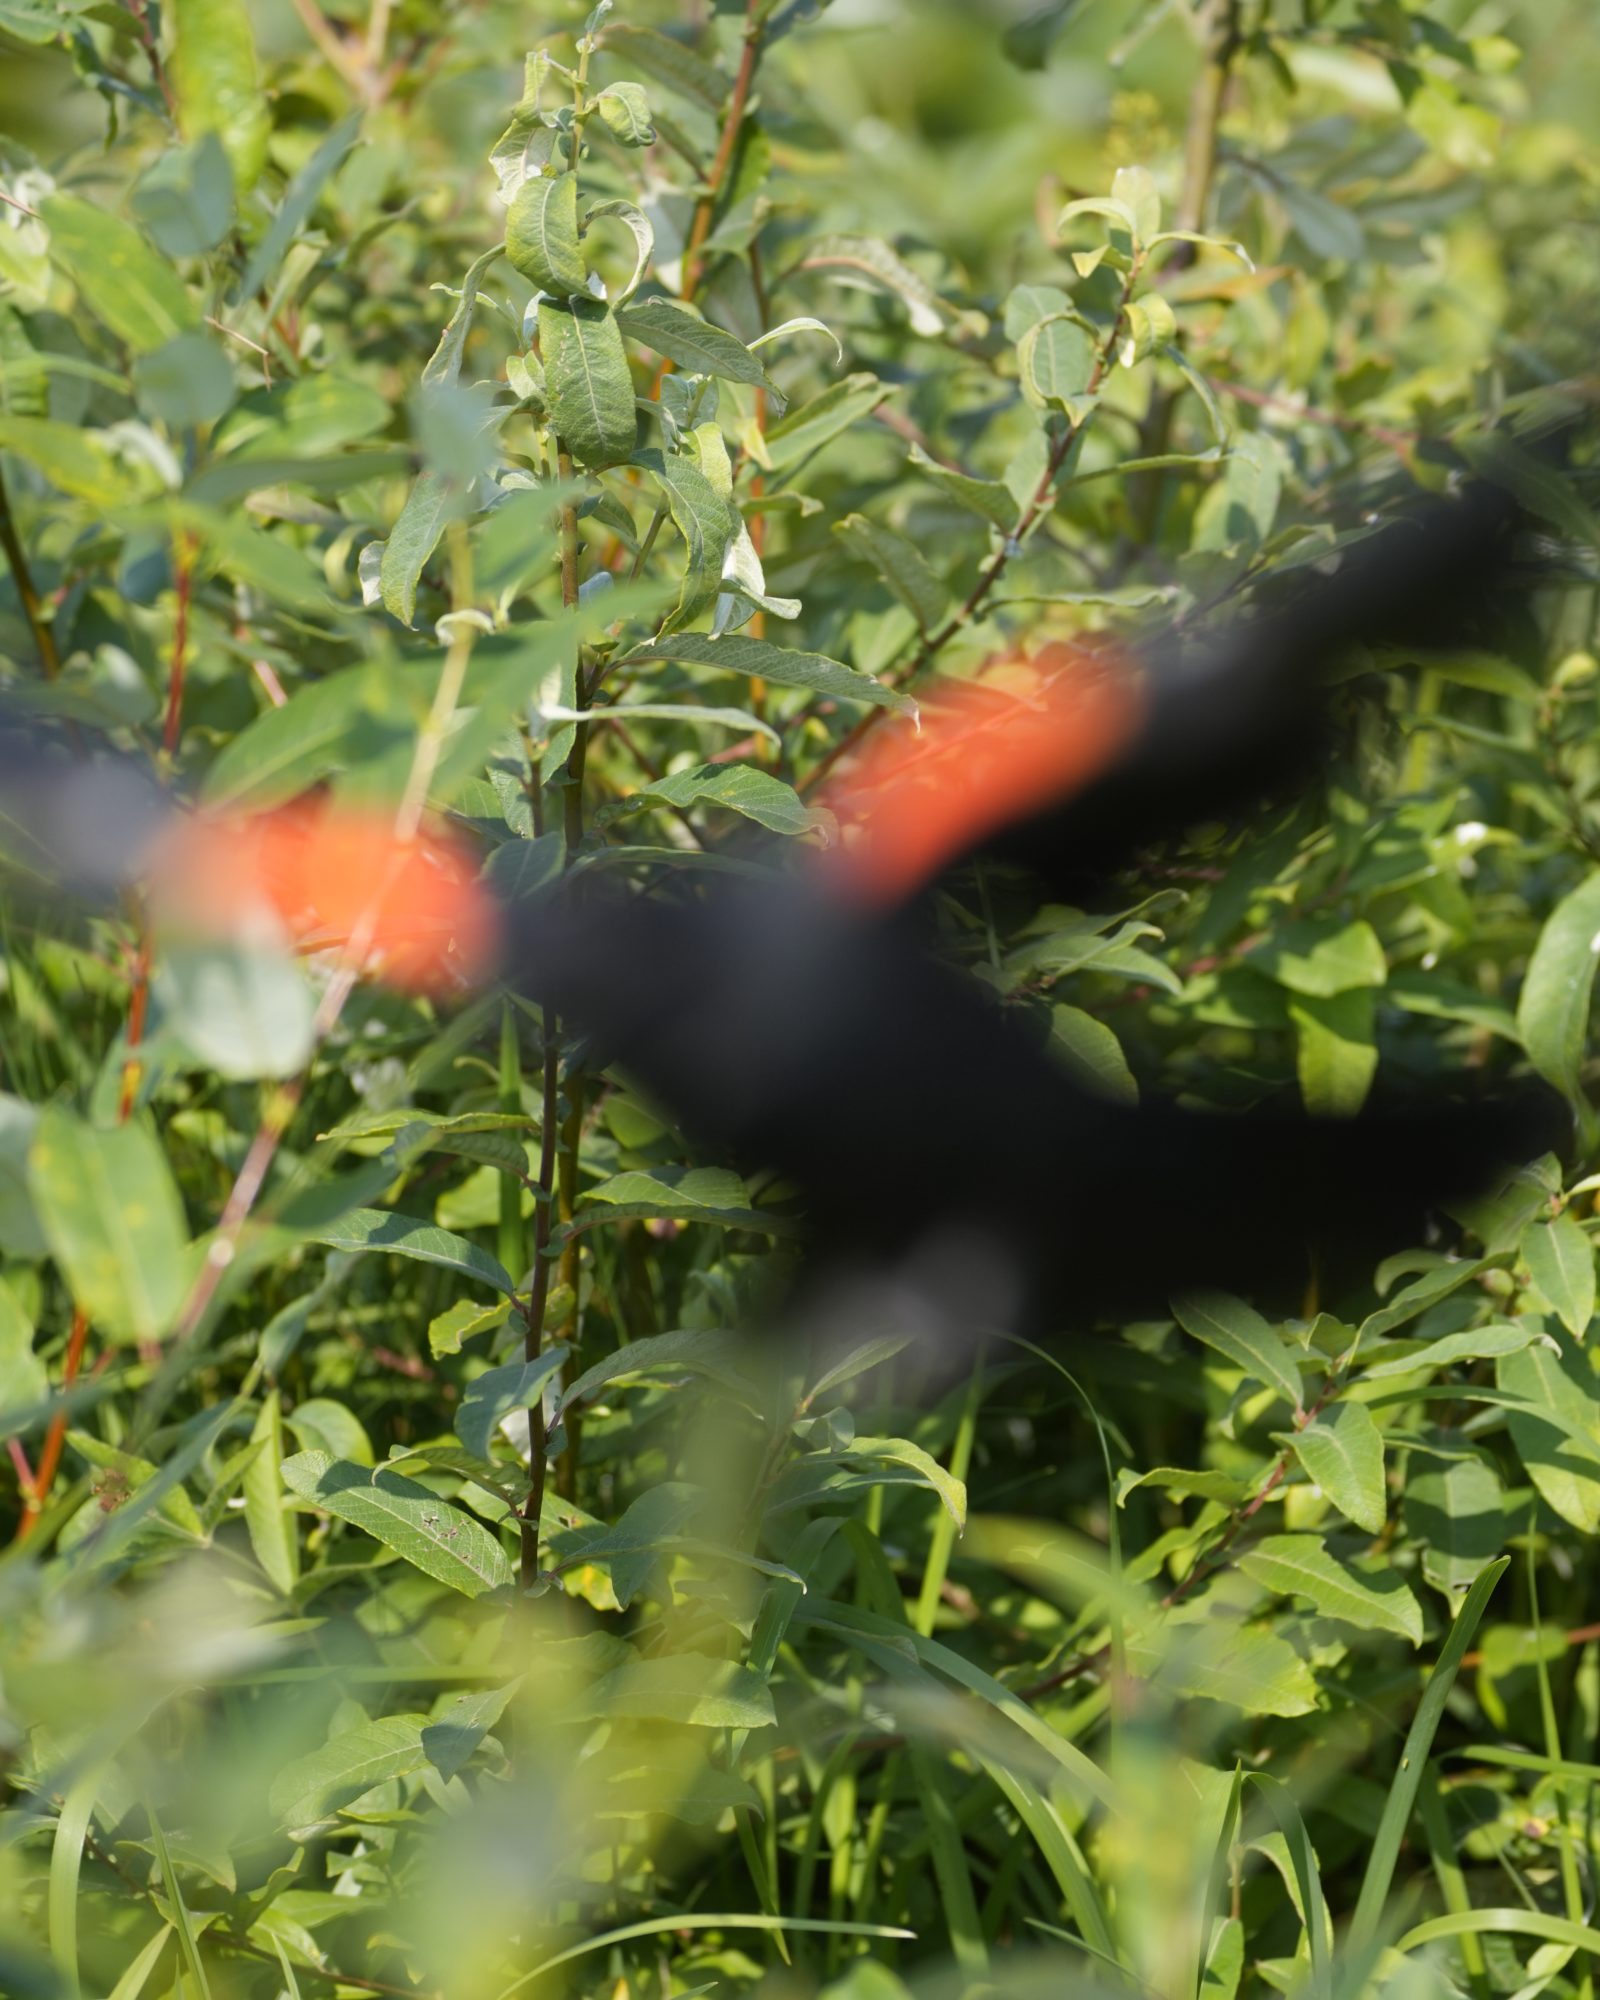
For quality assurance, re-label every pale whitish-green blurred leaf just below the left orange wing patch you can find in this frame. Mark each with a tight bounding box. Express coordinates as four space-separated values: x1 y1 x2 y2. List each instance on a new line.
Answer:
152 936 316 1082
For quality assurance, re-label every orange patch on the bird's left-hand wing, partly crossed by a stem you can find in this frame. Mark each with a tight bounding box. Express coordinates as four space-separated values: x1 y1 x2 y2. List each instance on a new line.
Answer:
154 806 496 992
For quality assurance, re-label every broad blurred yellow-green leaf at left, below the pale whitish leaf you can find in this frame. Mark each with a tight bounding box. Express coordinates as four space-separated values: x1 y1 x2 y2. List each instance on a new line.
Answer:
28 1104 190 1342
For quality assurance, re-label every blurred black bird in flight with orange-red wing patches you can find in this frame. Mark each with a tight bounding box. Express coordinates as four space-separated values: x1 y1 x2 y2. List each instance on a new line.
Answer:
0 476 1568 1324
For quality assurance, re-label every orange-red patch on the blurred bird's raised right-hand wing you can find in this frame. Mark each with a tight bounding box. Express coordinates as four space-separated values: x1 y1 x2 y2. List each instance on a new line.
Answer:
818 646 1144 906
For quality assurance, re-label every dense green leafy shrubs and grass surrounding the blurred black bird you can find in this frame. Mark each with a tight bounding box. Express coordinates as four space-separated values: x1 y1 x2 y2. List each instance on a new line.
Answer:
0 0 1600 2000
